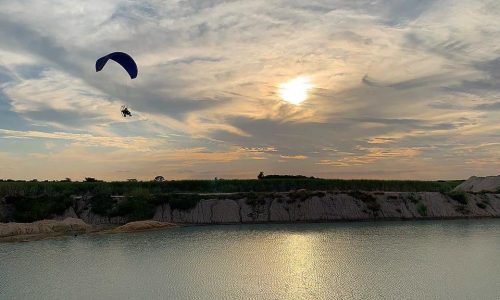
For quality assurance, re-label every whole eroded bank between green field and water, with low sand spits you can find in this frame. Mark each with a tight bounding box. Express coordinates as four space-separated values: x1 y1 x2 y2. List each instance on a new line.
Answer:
0 190 500 238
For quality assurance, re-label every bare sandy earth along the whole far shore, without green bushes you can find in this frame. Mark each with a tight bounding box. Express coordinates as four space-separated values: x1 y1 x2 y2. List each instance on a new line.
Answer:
0 190 500 233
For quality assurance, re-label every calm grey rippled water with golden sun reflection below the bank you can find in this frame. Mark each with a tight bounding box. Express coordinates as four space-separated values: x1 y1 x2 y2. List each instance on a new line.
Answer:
0 220 500 299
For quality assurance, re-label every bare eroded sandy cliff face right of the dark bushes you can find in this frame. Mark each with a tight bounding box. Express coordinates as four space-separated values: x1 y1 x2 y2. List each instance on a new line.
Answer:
153 192 500 224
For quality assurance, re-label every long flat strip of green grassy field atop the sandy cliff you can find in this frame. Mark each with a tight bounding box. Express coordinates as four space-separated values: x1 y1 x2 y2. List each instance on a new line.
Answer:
0 178 461 197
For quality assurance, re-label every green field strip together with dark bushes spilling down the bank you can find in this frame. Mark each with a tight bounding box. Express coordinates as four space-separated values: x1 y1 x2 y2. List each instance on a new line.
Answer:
0 178 463 222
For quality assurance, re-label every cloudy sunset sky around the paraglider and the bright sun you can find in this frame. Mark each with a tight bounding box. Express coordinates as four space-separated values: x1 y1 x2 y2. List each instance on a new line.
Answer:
0 0 500 180
